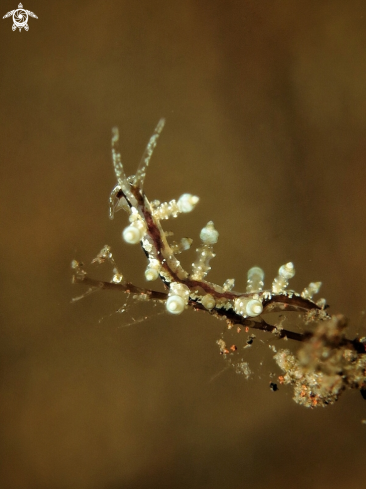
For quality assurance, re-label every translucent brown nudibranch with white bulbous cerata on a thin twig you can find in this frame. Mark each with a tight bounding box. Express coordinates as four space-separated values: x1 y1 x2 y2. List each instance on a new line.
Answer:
109 119 326 319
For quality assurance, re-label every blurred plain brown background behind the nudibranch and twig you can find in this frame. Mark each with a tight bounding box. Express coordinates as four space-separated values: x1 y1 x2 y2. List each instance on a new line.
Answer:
0 0 366 489
